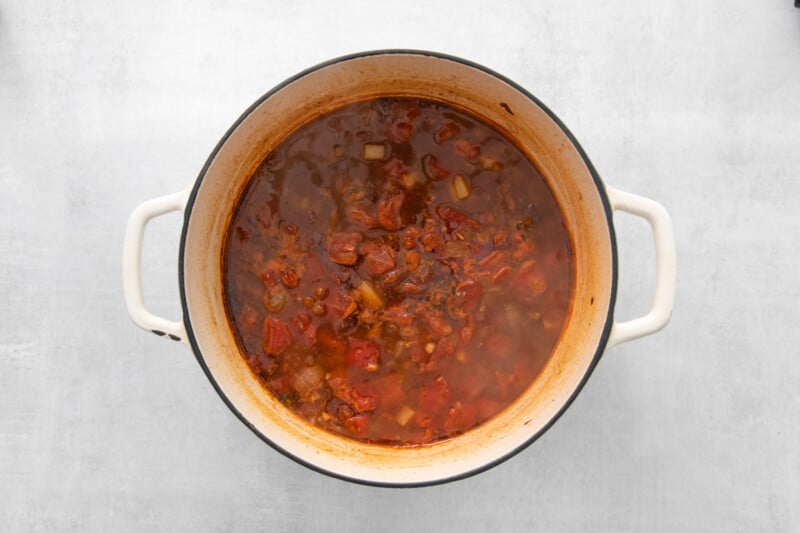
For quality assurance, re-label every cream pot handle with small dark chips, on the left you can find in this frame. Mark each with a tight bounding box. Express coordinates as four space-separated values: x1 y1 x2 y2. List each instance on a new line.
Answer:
122 188 191 345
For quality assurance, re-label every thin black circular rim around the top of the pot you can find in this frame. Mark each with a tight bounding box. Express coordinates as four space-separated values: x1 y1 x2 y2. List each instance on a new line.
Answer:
178 48 618 488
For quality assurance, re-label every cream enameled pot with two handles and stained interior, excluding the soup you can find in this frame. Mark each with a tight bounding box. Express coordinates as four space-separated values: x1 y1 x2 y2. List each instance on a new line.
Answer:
123 50 675 486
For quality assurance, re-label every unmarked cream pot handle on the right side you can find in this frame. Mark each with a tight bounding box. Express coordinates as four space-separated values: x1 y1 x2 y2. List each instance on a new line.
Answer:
606 187 676 347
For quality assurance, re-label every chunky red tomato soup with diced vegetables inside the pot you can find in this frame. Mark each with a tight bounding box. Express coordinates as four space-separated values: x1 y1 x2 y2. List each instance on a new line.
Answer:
224 98 574 445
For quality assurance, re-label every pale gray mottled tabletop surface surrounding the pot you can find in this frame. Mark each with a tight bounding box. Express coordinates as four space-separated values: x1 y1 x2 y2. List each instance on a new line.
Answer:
0 0 800 531
